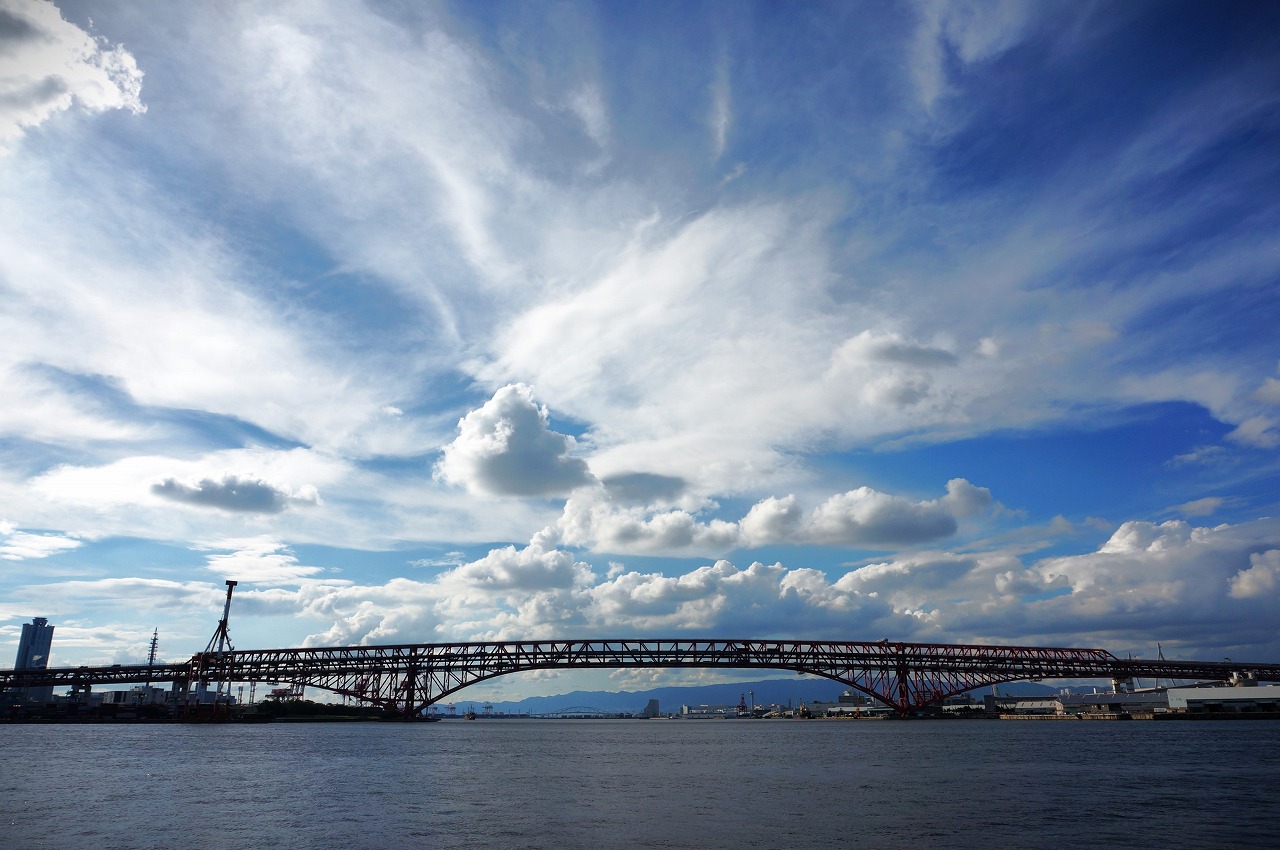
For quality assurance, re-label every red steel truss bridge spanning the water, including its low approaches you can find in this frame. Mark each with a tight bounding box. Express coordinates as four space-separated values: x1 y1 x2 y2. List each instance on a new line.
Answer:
0 637 1280 716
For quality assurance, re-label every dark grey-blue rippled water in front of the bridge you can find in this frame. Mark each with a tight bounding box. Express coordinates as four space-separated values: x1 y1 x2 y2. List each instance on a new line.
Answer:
0 719 1280 850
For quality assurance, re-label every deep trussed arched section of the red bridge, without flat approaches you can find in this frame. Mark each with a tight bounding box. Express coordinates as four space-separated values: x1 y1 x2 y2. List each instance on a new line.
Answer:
210 639 1141 714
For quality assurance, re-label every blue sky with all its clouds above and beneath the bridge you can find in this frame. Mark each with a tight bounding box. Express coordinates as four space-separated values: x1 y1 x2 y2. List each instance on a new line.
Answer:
0 0 1280 699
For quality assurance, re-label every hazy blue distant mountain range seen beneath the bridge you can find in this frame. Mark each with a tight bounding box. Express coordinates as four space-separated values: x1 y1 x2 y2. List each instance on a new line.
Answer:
438 677 1061 714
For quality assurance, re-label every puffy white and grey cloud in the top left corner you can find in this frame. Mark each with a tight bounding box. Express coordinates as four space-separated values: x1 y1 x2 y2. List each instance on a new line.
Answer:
0 0 146 151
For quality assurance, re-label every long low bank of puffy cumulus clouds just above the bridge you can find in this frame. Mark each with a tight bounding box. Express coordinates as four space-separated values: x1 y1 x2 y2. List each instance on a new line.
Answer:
17 512 1280 658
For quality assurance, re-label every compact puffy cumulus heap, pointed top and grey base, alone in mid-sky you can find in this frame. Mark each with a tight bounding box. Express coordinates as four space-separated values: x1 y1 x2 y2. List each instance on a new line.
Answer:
435 384 594 495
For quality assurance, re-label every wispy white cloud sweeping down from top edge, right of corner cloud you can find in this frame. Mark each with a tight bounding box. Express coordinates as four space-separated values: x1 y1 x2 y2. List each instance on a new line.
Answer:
183 3 529 291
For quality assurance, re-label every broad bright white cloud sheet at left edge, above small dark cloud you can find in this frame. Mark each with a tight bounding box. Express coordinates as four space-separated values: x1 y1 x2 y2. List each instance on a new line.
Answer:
0 157 426 454
